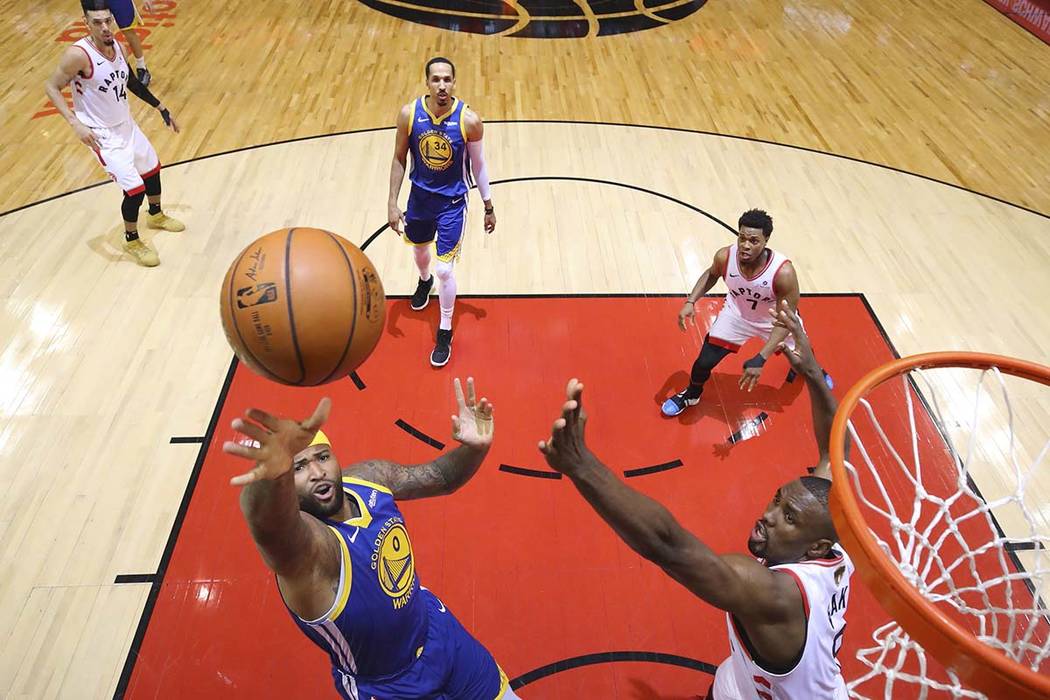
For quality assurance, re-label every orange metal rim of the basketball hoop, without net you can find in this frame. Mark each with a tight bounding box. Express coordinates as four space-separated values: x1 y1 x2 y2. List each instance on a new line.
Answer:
831 353 1050 700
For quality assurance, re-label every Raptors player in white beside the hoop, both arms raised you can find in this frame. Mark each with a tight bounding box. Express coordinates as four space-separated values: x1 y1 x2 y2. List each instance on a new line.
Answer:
540 299 853 700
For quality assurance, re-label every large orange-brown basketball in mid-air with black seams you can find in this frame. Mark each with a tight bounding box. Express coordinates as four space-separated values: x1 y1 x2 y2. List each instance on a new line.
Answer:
219 228 386 386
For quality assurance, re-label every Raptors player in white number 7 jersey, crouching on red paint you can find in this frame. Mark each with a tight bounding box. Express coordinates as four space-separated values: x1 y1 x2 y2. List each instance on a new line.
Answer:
662 209 832 416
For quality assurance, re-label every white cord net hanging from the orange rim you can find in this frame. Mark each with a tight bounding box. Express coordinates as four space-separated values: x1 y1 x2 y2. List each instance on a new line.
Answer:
846 367 1050 698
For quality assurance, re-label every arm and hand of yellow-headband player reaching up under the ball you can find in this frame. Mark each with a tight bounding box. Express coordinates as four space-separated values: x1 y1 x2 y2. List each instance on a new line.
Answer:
223 399 339 619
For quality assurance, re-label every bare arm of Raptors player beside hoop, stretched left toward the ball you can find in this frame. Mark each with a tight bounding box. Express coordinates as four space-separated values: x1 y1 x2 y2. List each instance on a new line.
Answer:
540 379 799 623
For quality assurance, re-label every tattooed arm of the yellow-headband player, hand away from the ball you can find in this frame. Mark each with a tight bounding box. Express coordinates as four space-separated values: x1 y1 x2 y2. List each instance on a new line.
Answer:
343 377 496 500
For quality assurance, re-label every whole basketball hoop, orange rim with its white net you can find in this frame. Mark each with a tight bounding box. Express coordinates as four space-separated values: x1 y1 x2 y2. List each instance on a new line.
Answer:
831 353 1050 700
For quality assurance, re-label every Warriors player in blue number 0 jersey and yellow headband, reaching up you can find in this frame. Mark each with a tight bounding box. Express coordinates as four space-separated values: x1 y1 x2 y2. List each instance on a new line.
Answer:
223 379 518 700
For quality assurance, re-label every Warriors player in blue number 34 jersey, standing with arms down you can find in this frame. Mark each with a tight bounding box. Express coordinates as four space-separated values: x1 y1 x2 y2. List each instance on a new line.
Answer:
387 58 496 367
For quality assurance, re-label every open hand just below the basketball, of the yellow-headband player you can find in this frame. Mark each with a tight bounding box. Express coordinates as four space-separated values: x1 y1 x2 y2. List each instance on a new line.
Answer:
223 398 332 486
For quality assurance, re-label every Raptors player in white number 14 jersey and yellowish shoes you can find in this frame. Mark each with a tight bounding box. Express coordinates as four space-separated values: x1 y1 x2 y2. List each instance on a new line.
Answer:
45 0 186 268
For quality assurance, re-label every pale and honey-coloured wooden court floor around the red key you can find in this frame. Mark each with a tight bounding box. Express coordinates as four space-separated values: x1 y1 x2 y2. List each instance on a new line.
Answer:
0 0 1050 698
